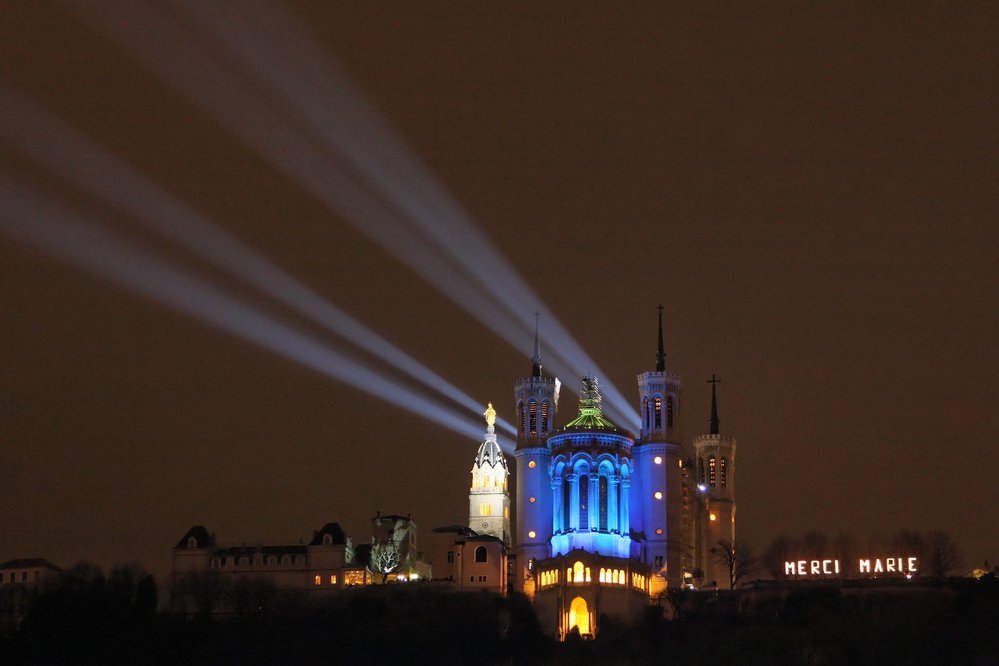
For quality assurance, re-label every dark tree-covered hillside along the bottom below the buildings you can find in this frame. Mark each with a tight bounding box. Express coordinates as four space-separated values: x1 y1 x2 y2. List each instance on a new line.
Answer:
0 567 999 666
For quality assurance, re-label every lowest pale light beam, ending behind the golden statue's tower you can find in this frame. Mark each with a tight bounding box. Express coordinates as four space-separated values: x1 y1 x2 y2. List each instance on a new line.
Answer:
0 173 512 452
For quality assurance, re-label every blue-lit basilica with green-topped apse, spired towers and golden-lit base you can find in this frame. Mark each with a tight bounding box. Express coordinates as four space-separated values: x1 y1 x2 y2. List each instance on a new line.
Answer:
513 311 736 637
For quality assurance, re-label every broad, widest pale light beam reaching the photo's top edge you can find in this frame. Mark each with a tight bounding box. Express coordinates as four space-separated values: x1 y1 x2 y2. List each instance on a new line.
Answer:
73 0 639 429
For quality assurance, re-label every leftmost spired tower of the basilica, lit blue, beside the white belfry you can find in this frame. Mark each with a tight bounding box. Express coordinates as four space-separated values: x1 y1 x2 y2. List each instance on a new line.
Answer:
513 314 560 590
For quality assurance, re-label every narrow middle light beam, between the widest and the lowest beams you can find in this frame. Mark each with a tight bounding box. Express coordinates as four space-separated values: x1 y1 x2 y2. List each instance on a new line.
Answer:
0 85 516 435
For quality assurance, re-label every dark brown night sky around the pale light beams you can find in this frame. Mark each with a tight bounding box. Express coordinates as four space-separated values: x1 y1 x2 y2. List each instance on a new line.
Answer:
0 2 999 574
